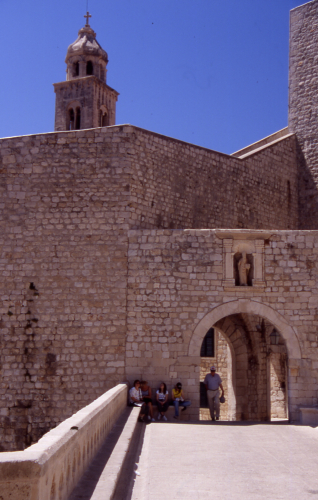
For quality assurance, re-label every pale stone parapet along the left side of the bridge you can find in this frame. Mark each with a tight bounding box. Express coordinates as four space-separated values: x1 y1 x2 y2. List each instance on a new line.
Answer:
0 384 127 500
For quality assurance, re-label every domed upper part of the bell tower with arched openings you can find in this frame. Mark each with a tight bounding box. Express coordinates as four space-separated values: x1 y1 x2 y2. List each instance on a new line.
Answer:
65 13 108 83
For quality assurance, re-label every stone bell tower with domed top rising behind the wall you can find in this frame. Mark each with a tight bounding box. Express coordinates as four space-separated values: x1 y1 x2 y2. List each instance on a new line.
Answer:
54 12 119 131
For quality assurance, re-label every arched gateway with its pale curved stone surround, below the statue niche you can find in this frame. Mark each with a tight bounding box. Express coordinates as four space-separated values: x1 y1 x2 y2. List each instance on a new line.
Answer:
189 300 301 421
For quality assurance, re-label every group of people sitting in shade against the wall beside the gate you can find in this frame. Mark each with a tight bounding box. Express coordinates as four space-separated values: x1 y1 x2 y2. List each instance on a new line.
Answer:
129 380 191 422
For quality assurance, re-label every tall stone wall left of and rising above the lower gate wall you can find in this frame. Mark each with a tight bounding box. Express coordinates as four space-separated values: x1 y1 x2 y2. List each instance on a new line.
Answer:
0 125 306 450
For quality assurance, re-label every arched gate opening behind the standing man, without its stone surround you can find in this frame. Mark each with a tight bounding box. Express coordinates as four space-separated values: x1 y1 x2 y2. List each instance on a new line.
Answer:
200 313 288 421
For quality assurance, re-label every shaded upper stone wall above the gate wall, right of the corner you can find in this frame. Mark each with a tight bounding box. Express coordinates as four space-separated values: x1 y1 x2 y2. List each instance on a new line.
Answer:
126 127 298 229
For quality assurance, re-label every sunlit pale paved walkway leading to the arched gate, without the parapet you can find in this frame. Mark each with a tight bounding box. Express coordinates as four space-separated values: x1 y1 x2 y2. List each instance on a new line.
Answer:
131 422 318 500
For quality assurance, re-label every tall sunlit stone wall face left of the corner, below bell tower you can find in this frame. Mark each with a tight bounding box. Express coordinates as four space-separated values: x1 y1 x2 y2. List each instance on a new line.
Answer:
0 129 129 450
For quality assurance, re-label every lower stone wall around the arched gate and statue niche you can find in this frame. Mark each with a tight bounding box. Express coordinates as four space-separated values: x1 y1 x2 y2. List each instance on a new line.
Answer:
126 230 318 420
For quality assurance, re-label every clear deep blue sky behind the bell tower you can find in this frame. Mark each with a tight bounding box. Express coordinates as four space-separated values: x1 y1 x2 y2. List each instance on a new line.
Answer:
0 0 303 153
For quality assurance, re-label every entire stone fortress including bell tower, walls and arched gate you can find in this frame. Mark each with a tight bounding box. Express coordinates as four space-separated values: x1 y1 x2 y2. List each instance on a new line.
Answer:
0 0 318 451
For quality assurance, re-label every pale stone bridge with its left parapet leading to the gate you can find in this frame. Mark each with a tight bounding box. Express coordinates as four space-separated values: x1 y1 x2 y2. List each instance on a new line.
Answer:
0 384 318 500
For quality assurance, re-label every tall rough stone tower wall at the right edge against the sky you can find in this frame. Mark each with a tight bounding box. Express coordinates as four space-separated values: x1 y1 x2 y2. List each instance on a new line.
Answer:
288 0 318 229
